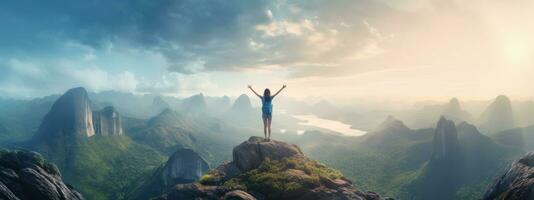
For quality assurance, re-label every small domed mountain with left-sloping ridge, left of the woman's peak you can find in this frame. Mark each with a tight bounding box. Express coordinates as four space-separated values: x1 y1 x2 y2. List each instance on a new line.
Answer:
128 149 209 200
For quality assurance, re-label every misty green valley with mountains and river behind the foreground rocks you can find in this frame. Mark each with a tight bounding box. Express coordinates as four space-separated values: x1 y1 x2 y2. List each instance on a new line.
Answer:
0 88 534 200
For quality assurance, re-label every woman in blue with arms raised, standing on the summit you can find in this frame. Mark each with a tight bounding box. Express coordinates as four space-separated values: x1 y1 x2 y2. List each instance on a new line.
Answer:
248 85 286 141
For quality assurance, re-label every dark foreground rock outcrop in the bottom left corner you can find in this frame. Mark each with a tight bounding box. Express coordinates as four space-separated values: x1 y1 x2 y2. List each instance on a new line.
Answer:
0 149 83 200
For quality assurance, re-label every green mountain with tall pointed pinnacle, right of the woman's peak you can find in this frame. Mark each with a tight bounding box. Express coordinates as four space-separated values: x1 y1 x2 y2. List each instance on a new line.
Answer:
408 117 517 200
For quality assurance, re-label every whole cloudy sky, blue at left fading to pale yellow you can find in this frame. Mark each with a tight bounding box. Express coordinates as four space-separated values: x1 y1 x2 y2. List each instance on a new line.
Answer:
0 0 534 101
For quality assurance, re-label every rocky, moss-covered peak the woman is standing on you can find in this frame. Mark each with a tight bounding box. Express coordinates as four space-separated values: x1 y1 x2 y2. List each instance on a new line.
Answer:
158 137 392 200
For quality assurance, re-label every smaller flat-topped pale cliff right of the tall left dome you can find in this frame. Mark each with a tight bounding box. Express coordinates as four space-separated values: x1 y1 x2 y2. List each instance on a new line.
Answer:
93 106 123 136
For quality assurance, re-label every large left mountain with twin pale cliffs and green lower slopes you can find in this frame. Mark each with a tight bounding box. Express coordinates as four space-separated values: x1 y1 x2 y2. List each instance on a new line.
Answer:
29 88 163 200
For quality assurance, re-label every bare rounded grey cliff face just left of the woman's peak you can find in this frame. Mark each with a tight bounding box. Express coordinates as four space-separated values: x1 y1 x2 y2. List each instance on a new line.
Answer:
161 149 209 188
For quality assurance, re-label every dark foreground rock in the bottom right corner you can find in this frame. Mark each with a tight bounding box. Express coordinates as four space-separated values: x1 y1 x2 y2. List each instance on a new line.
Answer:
484 152 534 200
